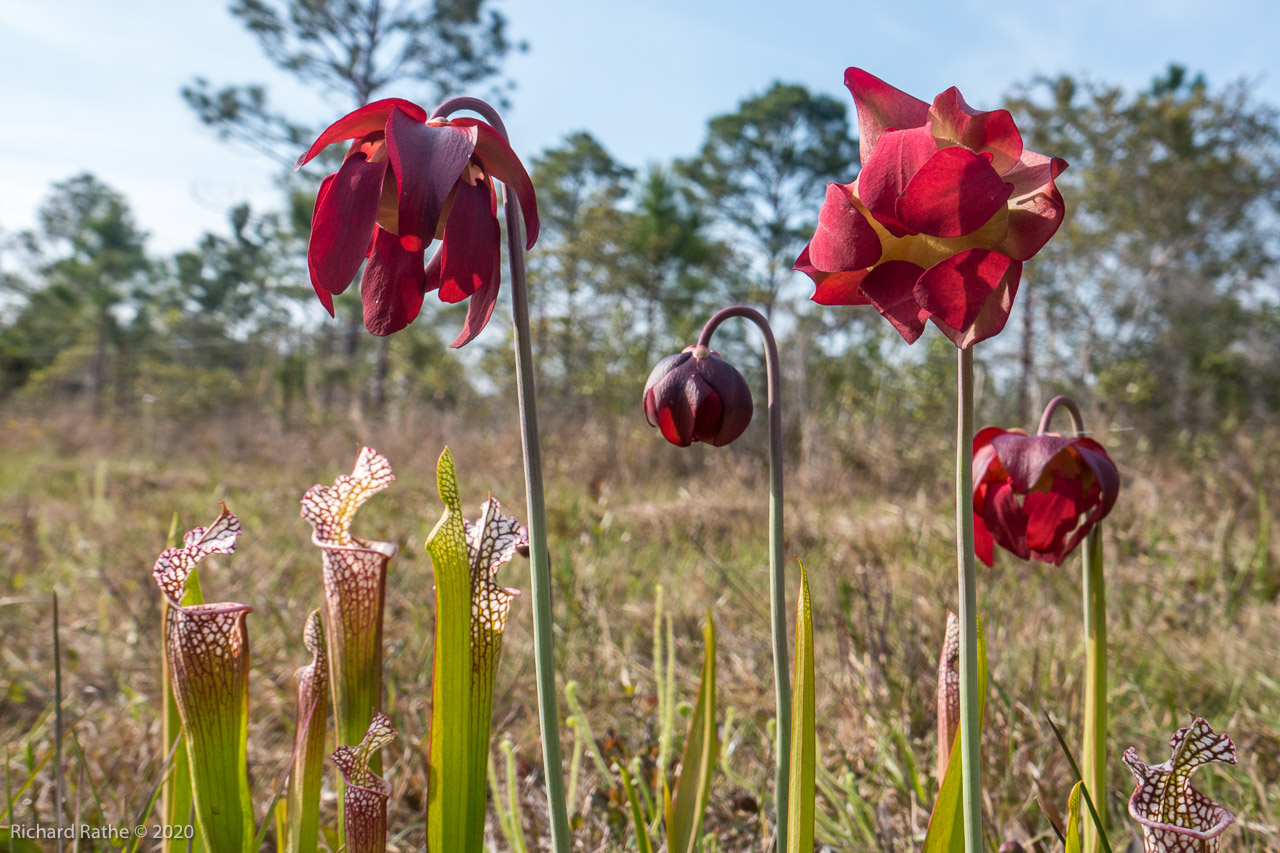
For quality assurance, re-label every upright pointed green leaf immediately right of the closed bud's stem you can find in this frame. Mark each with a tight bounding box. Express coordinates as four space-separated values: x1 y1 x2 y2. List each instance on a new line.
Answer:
783 562 818 853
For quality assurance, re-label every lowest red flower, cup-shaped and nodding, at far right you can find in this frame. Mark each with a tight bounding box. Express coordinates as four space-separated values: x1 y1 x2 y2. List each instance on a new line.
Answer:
973 427 1120 566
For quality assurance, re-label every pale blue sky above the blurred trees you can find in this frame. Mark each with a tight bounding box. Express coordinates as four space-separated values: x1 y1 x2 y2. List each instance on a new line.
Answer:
0 0 1280 252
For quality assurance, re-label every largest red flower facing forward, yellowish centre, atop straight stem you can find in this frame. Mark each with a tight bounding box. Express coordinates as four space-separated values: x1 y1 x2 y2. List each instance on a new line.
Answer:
795 68 1066 348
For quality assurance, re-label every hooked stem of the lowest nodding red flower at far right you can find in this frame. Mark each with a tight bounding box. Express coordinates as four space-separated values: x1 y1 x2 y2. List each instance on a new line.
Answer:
1038 394 1107 853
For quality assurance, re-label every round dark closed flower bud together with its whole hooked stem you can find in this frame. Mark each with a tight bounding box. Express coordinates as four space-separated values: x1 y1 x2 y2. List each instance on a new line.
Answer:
644 305 791 844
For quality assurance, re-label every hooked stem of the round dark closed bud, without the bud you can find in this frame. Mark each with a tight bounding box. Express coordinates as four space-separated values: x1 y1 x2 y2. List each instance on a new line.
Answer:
698 305 791 849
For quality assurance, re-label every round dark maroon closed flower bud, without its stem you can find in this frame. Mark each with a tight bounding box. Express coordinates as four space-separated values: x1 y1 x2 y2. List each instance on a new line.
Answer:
644 346 753 447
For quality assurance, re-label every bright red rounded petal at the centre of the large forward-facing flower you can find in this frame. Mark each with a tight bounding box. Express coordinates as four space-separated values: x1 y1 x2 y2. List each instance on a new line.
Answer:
897 149 1014 237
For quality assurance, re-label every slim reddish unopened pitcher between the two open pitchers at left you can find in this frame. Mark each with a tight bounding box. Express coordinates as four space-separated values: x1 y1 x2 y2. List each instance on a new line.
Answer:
284 610 329 853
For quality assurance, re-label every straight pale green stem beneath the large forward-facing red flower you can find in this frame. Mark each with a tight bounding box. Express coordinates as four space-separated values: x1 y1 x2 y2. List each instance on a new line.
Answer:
956 347 983 853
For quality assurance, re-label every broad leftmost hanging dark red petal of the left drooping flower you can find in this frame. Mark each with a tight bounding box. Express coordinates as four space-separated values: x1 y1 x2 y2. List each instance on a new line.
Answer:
307 154 387 293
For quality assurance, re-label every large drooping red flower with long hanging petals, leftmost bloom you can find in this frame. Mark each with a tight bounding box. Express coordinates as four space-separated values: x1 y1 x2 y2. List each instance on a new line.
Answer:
297 97 538 347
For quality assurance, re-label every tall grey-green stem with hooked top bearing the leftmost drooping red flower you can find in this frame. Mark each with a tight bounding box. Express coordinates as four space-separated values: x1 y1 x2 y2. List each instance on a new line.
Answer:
431 97 570 853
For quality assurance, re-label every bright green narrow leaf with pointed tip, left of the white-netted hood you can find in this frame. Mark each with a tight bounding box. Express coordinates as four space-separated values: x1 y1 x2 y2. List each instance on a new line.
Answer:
426 448 471 853
